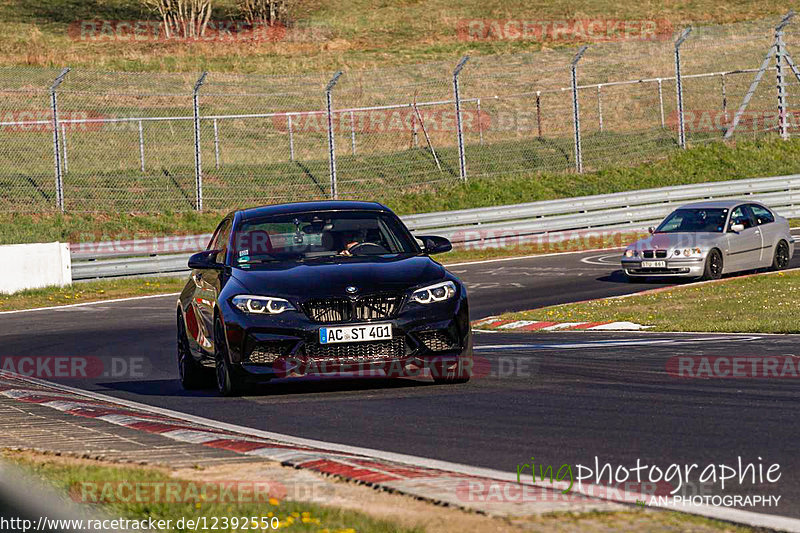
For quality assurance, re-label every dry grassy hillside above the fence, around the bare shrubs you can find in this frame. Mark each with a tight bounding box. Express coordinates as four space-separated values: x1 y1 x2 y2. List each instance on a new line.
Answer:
0 0 793 73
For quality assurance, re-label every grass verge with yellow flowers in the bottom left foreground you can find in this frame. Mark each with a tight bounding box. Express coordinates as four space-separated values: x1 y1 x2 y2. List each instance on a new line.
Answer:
6 454 422 533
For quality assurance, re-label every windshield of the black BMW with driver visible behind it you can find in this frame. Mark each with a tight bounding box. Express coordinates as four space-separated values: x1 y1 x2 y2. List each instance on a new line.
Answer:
233 211 420 265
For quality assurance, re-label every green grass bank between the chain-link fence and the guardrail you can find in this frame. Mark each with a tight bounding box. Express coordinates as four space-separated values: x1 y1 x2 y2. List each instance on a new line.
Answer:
0 139 800 244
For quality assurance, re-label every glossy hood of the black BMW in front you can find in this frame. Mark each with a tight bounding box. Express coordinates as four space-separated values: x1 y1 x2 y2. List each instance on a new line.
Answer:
232 252 446 298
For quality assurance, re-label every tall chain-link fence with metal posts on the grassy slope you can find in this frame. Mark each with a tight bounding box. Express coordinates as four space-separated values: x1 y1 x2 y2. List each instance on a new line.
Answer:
0 12 800 212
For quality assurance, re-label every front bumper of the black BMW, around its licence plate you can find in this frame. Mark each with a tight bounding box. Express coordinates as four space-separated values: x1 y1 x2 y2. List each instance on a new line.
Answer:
219 297 472 382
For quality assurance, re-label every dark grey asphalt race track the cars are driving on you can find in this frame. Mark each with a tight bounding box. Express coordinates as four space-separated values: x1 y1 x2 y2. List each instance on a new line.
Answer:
0 247 800 517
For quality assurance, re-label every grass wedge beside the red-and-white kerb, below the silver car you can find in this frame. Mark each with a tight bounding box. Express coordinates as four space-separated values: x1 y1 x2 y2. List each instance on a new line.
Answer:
490 270 800 333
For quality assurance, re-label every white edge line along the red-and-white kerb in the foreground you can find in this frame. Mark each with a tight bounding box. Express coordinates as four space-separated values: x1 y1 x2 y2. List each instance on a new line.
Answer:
10 376 800 533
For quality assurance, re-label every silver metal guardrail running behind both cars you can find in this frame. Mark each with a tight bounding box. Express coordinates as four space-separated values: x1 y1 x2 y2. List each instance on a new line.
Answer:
72 174 800 280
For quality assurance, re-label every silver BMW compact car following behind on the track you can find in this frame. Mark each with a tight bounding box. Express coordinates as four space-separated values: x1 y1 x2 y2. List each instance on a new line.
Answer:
622 200 794 279
